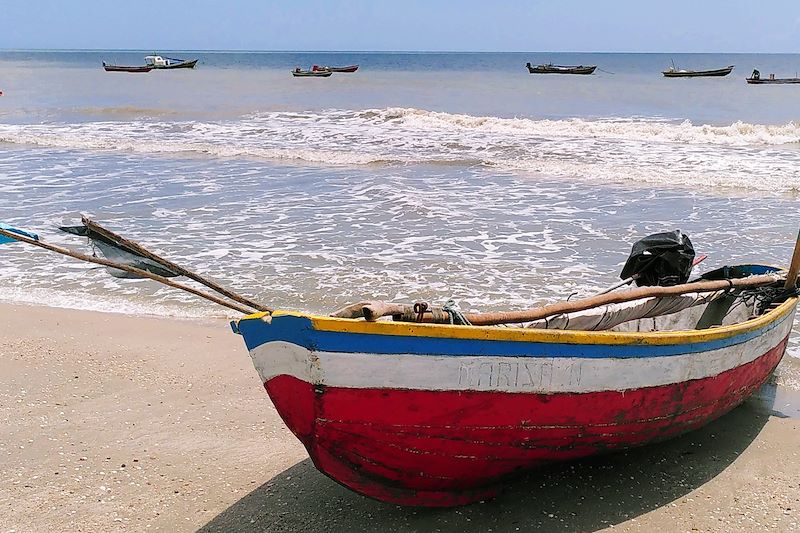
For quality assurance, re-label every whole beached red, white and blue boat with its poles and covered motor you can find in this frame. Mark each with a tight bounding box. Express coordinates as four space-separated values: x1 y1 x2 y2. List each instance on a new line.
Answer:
0 221 800 507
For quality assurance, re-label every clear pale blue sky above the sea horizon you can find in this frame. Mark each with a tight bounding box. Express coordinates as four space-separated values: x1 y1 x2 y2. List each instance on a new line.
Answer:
0 0 800 53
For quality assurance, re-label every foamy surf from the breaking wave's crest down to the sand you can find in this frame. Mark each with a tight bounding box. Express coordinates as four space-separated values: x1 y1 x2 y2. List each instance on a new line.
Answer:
0 108 800 360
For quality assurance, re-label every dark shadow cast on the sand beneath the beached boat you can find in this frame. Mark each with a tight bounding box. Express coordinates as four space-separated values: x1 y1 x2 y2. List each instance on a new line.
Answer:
200 384 784 532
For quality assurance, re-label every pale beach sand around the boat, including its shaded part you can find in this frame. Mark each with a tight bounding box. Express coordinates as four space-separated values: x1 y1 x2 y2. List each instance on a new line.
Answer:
0 305 800 532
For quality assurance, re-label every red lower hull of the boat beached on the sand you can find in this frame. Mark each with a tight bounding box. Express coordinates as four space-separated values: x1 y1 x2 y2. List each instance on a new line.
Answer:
265 339 787 507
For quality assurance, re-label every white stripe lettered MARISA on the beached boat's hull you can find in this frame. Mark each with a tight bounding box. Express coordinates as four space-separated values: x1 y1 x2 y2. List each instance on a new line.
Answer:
250 313 794 393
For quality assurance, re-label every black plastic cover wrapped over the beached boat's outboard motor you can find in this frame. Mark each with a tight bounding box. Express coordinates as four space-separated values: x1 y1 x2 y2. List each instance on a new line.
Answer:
619 230 694 286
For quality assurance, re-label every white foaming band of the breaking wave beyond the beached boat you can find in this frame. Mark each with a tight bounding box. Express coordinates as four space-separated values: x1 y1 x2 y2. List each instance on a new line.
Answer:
0 108 800 192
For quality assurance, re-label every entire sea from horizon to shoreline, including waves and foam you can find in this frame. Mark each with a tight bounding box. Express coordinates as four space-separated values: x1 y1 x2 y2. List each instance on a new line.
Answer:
0 51 800 372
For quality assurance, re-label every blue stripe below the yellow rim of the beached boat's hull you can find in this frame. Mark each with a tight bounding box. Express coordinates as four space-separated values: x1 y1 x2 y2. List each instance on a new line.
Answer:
234 313 792 358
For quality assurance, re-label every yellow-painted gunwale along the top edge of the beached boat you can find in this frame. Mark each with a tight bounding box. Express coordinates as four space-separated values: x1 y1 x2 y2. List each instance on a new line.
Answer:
239 296 798 345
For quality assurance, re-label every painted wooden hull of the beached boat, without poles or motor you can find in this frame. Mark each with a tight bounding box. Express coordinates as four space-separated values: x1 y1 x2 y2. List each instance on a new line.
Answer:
232 265 797 506
